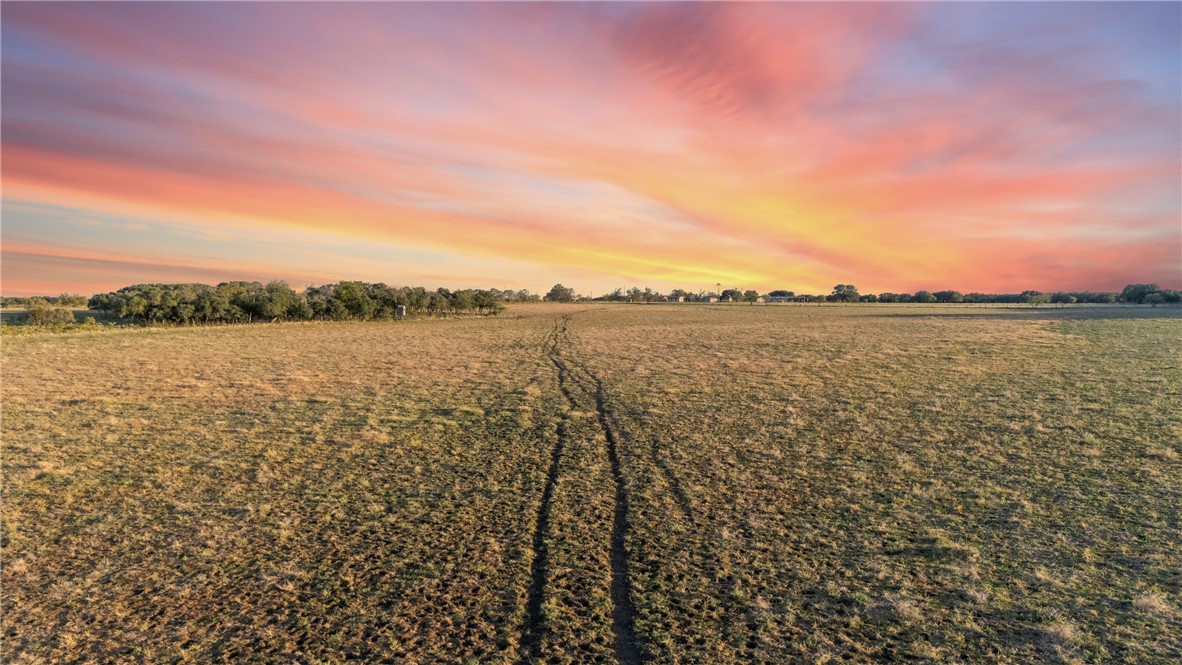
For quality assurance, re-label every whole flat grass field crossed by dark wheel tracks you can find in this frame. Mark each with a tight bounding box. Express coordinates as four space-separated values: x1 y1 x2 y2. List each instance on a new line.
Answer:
0 305 1182 664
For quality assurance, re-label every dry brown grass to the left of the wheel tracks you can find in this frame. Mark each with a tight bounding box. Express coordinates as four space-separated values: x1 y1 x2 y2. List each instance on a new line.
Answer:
4 318 572 663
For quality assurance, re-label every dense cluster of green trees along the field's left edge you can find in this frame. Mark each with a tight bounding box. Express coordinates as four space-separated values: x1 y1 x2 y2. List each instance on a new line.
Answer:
89 281 532 324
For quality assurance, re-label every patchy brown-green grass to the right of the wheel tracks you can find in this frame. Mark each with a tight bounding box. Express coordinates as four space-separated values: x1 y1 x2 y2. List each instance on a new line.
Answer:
571 306 1182 663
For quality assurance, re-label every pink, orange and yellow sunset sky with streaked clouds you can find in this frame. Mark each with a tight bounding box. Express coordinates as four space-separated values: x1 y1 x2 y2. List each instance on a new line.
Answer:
0 2 1182 295
